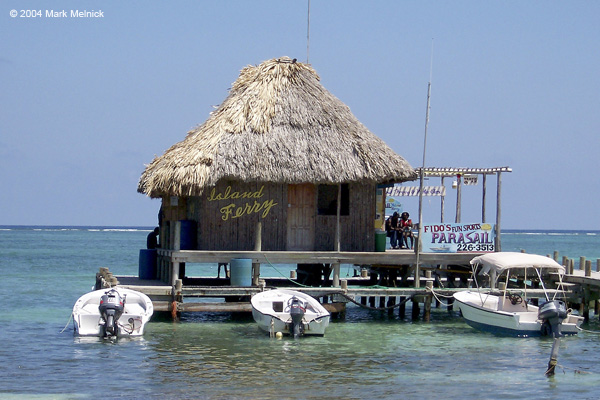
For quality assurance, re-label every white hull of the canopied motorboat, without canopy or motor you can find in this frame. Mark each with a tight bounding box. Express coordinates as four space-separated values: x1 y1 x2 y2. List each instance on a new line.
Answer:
454 291 583 337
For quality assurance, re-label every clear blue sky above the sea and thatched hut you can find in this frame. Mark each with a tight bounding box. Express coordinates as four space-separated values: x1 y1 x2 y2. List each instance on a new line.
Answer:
0 0 600 230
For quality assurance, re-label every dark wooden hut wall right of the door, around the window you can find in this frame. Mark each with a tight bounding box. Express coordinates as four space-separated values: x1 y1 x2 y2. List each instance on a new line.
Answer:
315 183 376 251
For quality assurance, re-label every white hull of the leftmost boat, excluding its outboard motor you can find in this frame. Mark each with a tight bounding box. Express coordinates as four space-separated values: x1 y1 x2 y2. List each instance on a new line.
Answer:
73 287 154 337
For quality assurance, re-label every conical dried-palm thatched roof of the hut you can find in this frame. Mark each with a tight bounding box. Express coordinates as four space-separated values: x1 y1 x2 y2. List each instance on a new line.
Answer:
138 57 416 197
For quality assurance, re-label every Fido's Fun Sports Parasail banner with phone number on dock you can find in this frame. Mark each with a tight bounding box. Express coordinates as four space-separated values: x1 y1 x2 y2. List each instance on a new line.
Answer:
421 223 496 253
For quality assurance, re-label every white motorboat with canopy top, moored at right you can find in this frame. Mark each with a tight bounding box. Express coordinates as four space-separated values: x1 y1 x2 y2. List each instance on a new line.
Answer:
454 252 583 337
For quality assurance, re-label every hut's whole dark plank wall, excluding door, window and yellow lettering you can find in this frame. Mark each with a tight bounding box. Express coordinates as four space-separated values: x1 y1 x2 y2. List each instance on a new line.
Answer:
161 181 376 251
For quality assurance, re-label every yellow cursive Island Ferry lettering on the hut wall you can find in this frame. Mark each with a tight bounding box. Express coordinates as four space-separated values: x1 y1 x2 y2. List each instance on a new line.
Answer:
207 185 278 221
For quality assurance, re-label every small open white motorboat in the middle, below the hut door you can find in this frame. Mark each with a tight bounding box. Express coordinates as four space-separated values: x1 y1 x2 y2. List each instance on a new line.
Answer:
250 289 330 337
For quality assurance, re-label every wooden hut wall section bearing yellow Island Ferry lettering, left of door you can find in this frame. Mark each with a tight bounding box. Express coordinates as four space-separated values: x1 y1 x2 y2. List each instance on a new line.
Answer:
188 181 287 250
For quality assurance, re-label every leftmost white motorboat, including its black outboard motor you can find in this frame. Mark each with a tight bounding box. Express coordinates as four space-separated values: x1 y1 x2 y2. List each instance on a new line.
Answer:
73 287 154 337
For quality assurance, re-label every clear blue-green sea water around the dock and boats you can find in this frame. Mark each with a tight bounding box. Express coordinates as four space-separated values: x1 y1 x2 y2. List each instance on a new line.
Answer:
0 226 600 399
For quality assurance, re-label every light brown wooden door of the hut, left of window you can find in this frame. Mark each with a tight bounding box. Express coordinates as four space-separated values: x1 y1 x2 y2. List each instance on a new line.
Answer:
287 183 317 250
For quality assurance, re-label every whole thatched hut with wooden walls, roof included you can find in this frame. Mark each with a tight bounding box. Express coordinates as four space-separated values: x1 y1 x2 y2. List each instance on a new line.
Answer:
138 57 416 251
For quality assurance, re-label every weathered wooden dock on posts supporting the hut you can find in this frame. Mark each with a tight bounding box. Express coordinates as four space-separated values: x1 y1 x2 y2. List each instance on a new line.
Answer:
97 250 600 321
